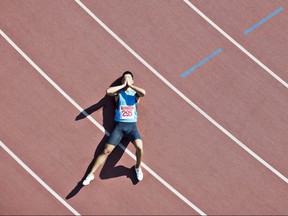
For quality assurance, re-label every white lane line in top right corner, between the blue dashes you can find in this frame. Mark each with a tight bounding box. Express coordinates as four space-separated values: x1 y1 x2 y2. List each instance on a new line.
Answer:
183 0 288 88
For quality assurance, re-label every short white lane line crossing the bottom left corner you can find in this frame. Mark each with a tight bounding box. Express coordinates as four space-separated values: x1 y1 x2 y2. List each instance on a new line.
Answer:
0 140 80 215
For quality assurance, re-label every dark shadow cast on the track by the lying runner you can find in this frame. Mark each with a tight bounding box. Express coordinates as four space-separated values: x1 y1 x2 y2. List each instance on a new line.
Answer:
66 77 138 199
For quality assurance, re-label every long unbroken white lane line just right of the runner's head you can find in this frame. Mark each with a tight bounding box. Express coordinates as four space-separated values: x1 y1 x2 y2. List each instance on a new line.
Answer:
75 0 288 186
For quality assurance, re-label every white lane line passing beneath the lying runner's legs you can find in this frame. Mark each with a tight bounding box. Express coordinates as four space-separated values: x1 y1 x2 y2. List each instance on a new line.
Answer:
0 29 206 215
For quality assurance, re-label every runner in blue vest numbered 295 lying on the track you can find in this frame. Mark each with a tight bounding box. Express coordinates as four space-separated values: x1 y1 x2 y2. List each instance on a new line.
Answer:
83 71 146 185
